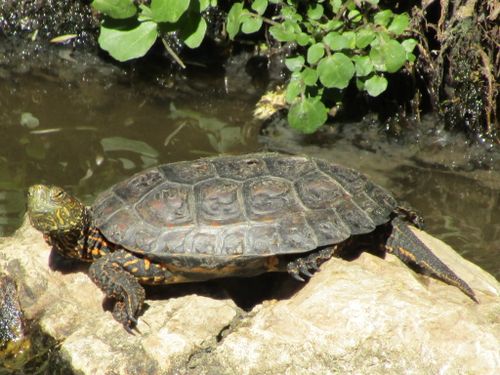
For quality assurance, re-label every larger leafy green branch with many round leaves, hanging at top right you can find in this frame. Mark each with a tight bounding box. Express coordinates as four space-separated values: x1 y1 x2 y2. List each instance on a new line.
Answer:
227 0 417 133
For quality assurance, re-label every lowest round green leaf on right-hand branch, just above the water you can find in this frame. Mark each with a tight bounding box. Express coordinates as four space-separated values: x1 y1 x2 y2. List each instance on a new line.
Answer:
288 96 328 134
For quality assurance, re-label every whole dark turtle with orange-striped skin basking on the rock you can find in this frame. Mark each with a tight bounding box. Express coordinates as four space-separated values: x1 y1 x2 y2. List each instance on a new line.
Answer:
27 153 477 332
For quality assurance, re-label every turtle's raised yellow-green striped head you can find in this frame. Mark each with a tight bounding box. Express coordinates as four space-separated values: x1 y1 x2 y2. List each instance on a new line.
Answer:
28 185 87 234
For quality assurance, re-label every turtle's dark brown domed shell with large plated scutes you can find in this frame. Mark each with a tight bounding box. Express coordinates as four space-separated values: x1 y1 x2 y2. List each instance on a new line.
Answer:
92 153 396 263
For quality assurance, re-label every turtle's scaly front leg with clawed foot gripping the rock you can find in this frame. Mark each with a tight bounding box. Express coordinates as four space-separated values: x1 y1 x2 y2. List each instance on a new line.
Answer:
89 250 145 332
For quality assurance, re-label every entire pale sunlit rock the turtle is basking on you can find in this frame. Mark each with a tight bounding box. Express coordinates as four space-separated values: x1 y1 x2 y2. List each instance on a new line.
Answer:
0 219 500 374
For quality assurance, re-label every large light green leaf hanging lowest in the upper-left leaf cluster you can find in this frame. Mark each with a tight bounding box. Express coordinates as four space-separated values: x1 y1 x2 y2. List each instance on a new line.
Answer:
98 21 158 61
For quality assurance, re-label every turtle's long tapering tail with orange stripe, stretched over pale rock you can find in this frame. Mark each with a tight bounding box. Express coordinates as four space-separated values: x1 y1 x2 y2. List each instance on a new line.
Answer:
385 217 478 302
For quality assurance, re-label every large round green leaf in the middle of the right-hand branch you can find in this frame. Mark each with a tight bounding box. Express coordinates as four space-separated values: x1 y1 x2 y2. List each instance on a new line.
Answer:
317 52 354 89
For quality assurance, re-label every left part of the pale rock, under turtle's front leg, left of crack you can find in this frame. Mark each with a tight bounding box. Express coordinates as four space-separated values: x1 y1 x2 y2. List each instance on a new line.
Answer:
0 219 239 374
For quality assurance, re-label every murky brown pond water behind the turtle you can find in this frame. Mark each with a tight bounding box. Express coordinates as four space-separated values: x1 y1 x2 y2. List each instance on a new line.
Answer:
0 47 500 284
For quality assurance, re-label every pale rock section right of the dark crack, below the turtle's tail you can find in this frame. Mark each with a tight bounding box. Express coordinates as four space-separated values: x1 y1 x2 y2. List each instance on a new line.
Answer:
200 232 500 374
